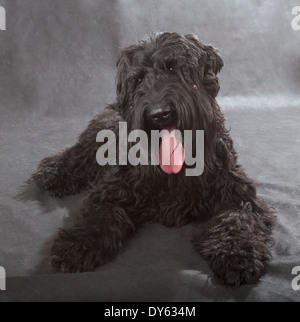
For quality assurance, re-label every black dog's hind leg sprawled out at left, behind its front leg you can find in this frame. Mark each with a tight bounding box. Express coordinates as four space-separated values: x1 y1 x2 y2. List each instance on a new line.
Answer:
32 109 120 197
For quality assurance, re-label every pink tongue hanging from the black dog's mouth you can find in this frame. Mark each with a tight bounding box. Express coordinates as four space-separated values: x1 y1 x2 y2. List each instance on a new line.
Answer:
159 128 184 174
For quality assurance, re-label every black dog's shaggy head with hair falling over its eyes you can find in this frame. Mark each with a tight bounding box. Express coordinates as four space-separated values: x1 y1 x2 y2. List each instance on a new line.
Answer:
117 32 223 176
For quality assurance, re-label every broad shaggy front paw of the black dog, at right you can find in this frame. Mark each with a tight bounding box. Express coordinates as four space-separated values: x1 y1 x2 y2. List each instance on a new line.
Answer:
194 200 273 286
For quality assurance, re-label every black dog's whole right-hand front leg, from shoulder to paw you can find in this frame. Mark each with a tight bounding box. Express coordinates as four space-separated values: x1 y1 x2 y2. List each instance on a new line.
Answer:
194 140 275 286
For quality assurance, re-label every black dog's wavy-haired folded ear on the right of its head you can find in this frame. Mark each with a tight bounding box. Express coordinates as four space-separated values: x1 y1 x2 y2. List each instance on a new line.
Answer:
185 35 224 98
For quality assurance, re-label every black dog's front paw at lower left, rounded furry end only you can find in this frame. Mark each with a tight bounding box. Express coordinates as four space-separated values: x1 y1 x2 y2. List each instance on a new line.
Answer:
50 226 111 273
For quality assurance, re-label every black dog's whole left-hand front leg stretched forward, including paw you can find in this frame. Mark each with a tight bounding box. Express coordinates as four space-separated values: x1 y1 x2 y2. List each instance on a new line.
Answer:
50 184 135 273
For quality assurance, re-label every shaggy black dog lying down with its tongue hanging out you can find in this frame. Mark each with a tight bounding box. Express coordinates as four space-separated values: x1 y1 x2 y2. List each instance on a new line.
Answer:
33 33 274 285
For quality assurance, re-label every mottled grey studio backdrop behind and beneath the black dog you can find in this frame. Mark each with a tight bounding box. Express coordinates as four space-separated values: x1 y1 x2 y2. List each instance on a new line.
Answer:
0 0 300 301
